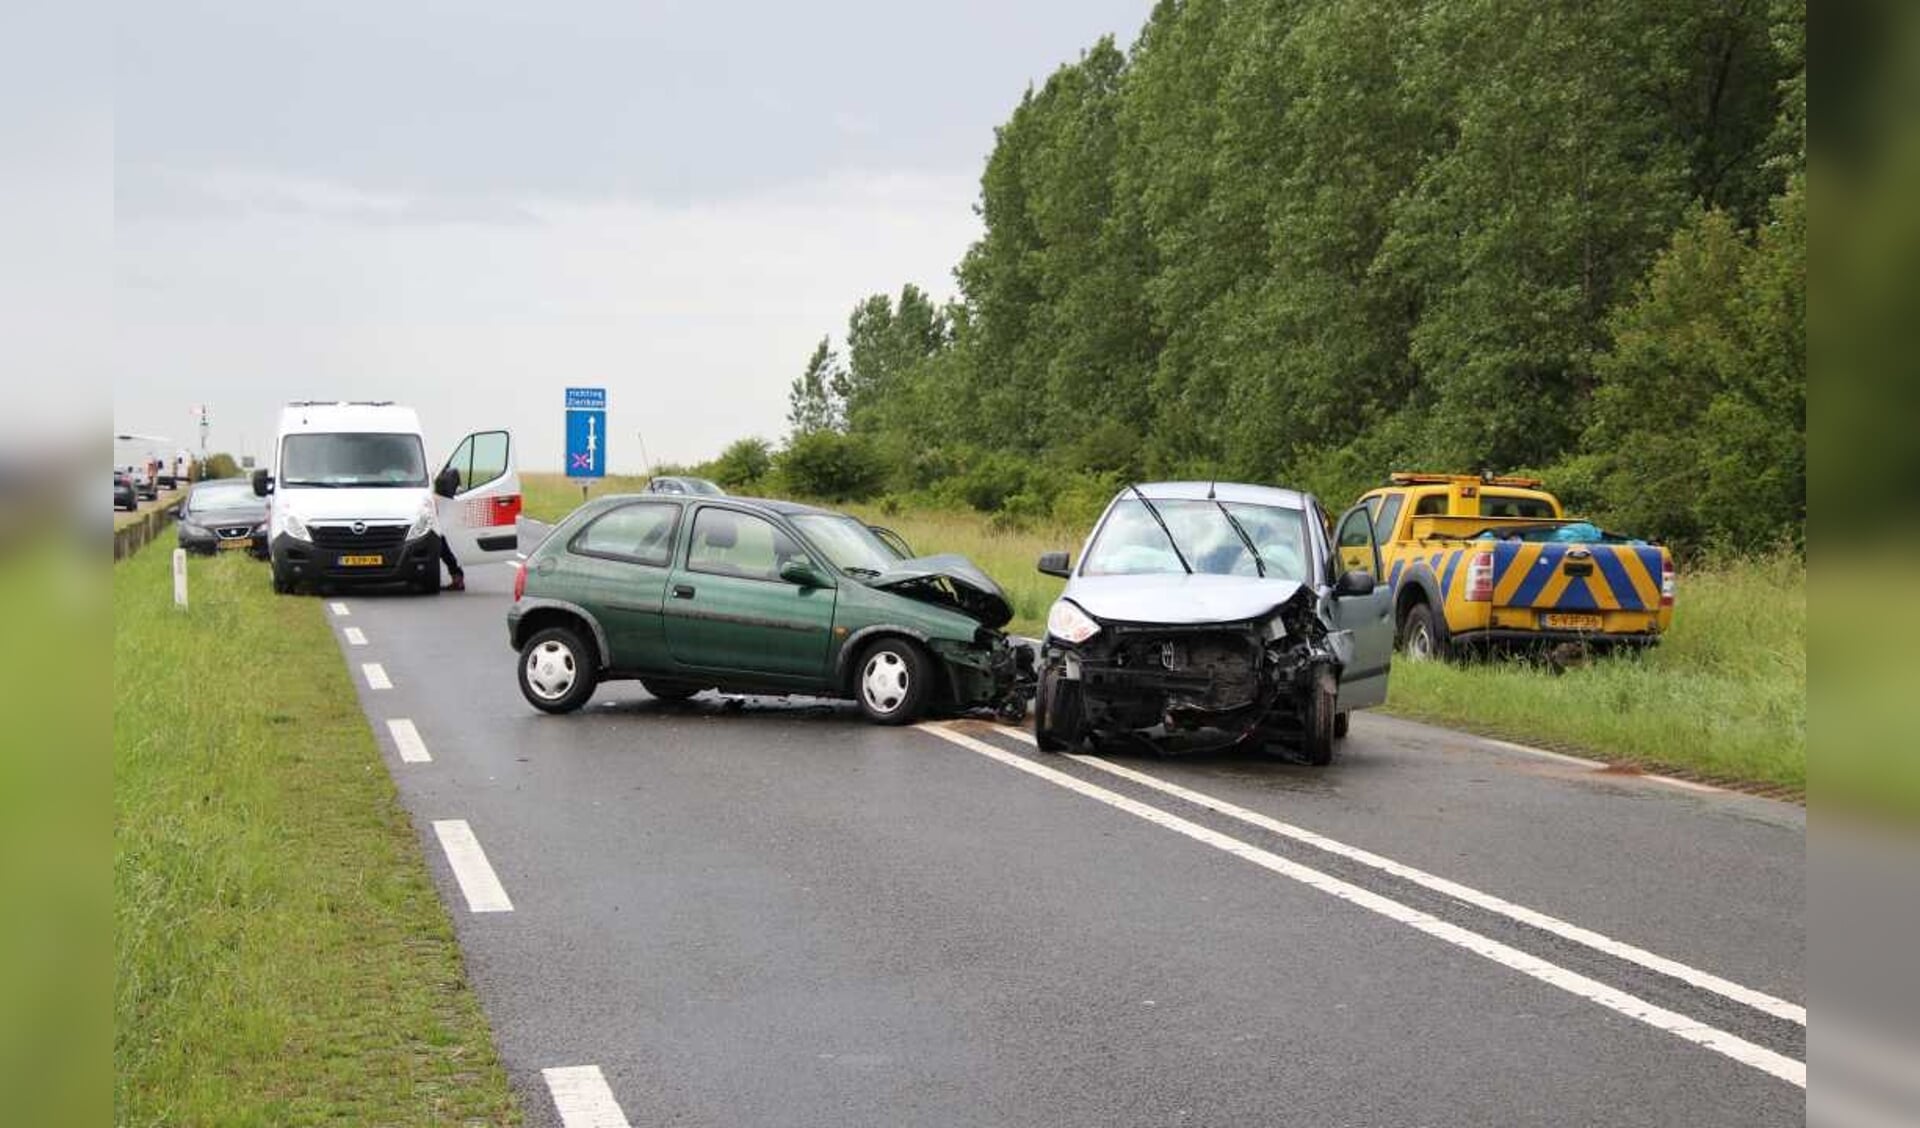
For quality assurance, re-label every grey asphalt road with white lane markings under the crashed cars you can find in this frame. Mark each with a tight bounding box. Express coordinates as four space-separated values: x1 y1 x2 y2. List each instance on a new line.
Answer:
328 568 1805 1128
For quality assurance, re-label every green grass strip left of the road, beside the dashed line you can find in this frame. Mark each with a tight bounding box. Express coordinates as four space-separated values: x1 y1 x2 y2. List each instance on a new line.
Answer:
113 552 520 1126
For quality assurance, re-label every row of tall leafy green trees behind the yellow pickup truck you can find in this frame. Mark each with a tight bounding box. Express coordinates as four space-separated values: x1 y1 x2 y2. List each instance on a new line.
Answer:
708 0 1807 549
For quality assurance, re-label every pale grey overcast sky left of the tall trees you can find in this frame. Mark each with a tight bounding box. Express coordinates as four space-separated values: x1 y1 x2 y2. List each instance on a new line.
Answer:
113 0 1150 470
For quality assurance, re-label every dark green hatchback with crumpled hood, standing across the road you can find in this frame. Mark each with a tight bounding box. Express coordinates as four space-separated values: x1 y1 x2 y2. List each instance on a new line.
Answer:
507 493 1033 725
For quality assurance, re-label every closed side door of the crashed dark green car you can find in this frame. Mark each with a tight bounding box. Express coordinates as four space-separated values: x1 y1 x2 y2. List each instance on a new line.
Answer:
664 505 835 687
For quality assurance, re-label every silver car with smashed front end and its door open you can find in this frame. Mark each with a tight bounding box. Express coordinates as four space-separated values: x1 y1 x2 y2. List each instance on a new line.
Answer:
1033 482 1394 764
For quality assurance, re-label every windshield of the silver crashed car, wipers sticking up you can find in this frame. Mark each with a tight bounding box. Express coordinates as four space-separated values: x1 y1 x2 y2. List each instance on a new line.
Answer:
1081 497 1308 581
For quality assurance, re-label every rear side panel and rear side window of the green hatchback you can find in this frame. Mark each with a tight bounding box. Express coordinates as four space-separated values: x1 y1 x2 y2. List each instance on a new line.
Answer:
566 501 682 673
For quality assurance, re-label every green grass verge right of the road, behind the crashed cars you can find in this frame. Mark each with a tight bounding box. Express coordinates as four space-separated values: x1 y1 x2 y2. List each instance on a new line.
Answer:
526 476 1807 798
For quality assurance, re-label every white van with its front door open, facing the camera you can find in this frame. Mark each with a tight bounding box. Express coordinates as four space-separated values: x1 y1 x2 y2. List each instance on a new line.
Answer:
253 401 520 593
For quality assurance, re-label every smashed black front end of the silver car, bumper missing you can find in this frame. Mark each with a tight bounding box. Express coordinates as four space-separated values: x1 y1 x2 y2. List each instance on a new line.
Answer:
1037 600 1348 744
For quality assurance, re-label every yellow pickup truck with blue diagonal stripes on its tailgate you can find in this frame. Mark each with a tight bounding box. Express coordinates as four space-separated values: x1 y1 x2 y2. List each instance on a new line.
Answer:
1334 474 1674 658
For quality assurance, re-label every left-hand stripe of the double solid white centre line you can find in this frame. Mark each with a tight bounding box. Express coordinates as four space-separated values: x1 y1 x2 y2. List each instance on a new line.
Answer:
920 725 1807 1090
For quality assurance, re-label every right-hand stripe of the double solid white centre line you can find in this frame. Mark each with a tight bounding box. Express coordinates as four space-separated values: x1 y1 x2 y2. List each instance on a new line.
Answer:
1008 729 1807 1026
